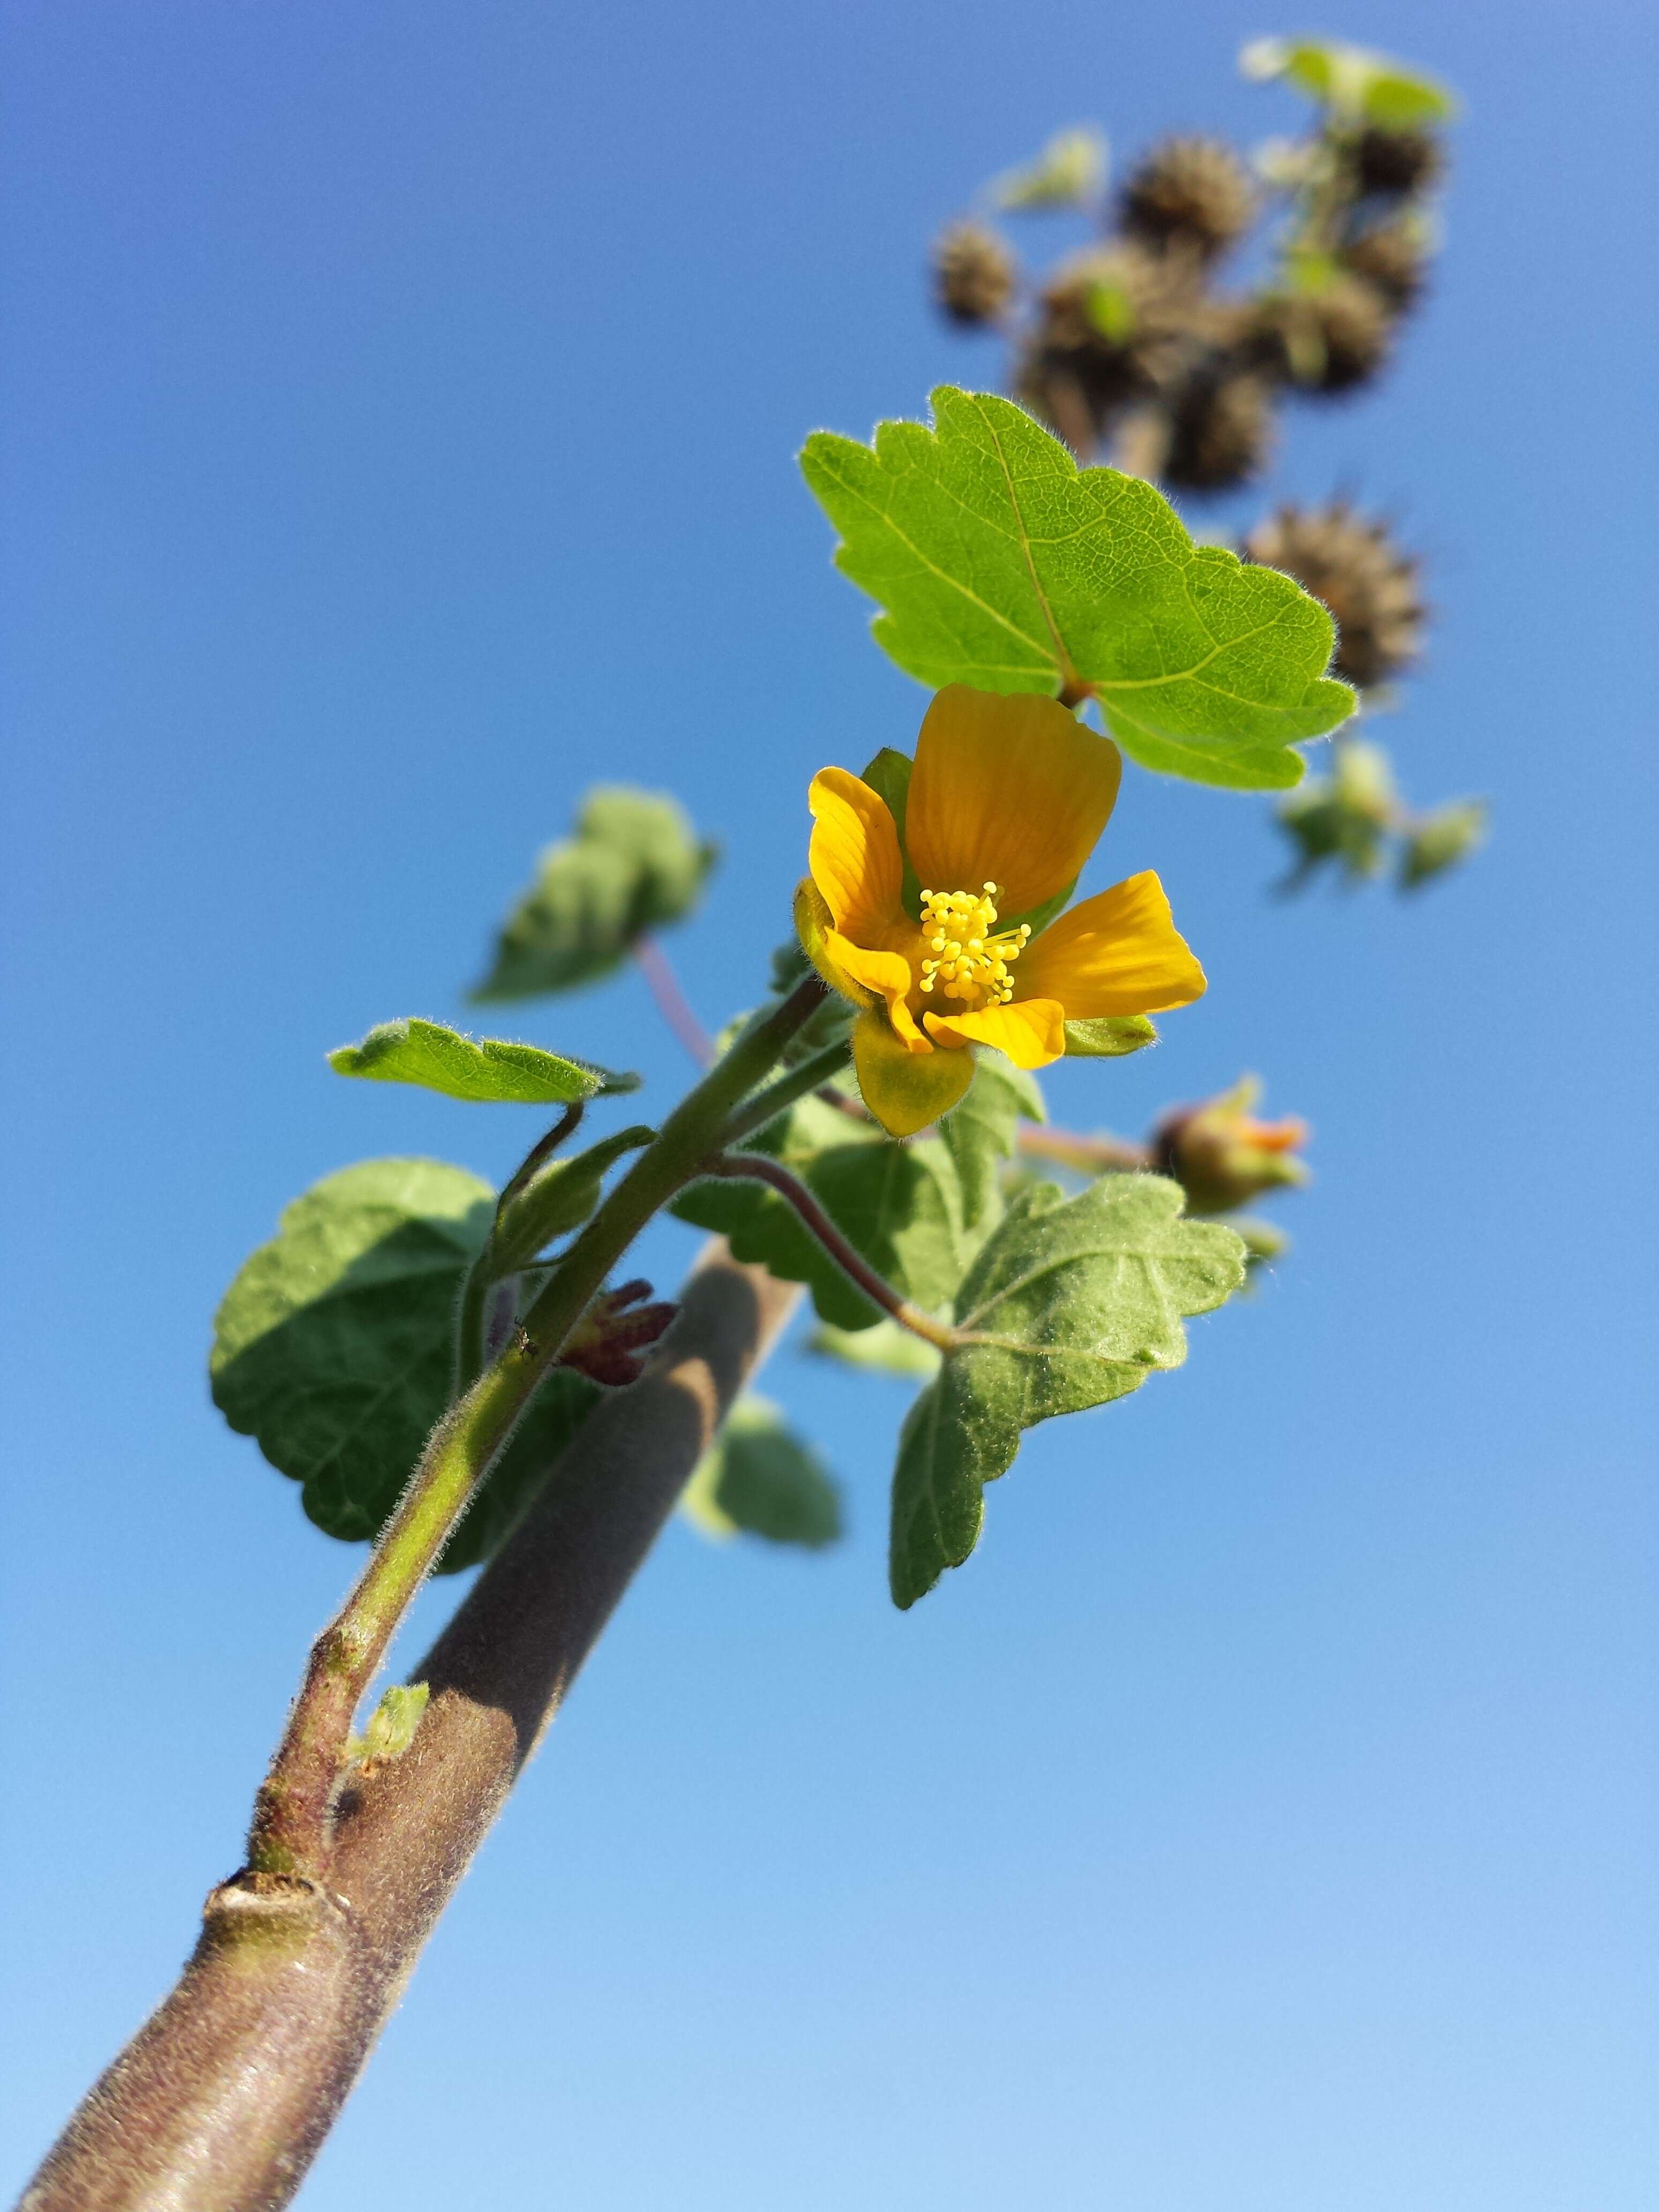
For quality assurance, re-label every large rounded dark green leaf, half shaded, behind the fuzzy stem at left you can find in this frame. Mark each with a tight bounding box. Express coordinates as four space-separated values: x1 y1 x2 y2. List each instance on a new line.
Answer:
210 1159 600 1571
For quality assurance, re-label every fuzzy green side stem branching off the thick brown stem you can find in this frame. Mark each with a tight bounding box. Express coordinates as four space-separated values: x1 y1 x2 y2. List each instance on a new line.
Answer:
248 975 827 1882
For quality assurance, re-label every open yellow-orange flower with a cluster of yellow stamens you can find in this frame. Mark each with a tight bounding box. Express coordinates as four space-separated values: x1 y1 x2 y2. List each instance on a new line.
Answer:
796 684 1204 1137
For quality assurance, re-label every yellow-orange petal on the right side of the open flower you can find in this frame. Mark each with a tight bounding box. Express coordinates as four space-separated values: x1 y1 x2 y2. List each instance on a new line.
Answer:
1013 871 1204 1022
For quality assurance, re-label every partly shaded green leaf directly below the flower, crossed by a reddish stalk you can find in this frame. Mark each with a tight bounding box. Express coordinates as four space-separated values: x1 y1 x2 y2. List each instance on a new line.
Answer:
672 1100 971 1329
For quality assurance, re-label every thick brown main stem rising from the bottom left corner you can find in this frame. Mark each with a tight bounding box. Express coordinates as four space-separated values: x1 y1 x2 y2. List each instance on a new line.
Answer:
20 1245 798 2212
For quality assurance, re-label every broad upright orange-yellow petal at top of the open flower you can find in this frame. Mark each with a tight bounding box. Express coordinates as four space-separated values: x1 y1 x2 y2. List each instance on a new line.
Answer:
902 684 1124 920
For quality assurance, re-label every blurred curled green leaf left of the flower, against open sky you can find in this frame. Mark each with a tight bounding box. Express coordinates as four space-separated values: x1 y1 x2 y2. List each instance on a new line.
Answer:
473 785 719 1000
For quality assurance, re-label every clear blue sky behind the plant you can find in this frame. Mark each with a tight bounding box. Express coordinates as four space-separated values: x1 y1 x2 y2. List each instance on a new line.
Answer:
0 0 1659 2212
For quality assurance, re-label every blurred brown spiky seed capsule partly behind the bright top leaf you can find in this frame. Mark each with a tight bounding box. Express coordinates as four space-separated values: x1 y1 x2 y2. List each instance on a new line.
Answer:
1245 500 1427 690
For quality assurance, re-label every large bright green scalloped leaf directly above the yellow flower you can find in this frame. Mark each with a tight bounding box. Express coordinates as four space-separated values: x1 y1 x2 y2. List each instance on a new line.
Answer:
801 385 1354 790
